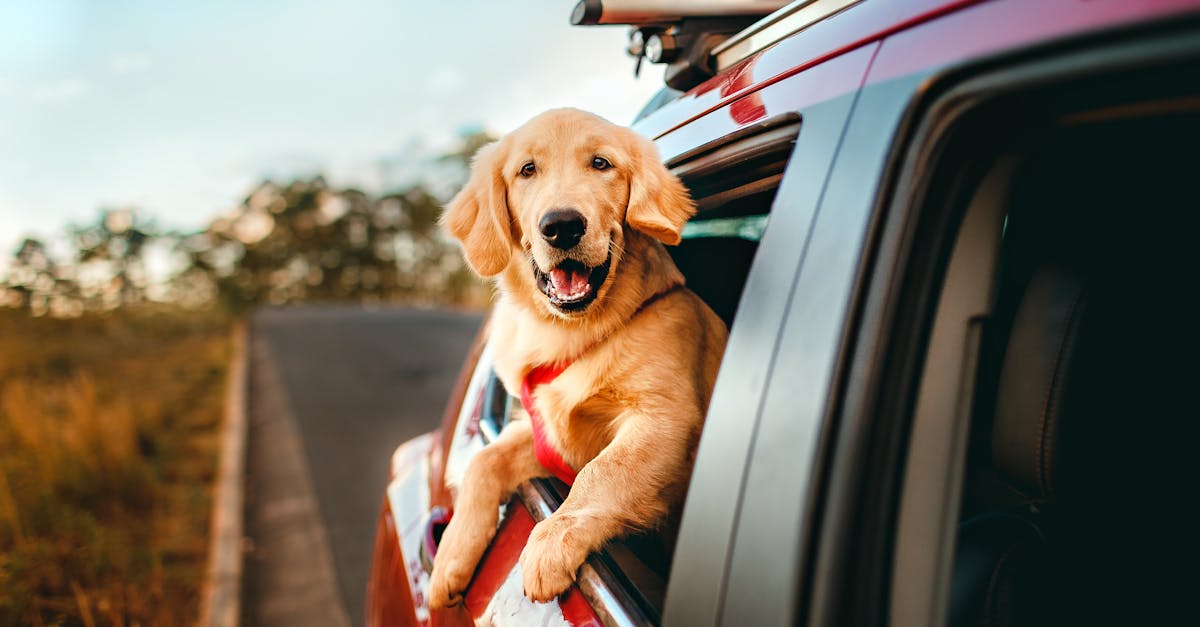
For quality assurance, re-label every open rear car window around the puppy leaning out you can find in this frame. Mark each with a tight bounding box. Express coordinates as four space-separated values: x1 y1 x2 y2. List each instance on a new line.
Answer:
479 115 800 625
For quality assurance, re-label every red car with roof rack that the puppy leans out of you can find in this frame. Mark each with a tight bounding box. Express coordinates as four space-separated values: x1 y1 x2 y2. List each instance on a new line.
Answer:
367 0 1200 626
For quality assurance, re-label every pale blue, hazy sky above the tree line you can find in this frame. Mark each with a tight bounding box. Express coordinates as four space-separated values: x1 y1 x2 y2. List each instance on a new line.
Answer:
0 0 662 264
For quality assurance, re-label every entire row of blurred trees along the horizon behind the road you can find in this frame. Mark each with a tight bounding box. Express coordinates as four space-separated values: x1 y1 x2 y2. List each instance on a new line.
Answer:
0 133 493 317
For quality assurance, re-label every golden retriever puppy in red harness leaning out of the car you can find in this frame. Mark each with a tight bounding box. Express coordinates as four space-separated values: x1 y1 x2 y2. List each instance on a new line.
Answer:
430 109 726 609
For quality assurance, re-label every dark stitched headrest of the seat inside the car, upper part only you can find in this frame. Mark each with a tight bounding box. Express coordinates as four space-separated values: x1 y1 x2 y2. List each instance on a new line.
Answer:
992 265 1086 500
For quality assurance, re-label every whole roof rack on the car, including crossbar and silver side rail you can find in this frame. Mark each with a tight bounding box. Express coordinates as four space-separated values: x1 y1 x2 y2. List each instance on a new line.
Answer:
571 0 862 91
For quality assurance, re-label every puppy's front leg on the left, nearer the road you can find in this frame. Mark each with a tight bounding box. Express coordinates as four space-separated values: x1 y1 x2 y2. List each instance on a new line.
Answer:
430 420 546 609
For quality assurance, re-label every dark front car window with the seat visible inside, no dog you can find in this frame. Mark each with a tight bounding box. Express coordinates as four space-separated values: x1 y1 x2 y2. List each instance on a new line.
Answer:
815 32 1200 626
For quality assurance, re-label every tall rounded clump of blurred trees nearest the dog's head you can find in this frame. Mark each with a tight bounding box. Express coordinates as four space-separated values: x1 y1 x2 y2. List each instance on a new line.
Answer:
192 172 468 310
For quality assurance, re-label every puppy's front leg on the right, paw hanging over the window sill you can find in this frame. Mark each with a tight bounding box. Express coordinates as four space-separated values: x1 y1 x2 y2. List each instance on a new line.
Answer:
521 416 691 602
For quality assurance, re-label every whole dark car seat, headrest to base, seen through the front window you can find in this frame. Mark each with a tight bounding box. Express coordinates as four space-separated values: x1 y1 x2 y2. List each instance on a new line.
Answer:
949 264 1087 627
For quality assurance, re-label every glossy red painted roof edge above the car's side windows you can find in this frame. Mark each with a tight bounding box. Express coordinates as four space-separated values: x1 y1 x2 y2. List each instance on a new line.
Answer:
636 0 1200 139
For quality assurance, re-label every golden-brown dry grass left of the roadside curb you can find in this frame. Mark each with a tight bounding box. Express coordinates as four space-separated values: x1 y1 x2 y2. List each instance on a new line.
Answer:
0 310 229 627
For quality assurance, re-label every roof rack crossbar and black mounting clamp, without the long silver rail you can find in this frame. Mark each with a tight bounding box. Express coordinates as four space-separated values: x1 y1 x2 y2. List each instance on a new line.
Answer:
571 0 787 91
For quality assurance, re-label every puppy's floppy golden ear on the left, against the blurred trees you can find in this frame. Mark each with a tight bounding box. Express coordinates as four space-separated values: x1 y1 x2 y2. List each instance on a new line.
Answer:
442 142 514 276
